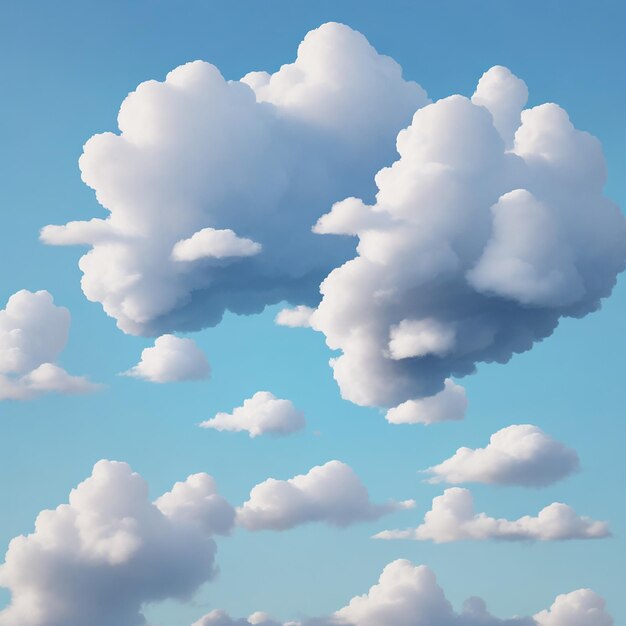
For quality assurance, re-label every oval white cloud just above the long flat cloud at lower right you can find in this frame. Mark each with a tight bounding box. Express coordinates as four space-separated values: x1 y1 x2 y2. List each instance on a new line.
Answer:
426 424 579 487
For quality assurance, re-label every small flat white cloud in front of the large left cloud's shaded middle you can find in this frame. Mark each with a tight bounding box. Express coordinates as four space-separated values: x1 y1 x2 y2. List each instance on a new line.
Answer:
172 228 261 261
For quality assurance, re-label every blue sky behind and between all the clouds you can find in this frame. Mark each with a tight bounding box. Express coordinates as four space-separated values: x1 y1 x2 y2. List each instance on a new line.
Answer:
0 0 626 626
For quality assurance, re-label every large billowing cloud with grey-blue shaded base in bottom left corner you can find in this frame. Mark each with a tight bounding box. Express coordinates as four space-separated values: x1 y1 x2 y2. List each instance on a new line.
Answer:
0 461 234 626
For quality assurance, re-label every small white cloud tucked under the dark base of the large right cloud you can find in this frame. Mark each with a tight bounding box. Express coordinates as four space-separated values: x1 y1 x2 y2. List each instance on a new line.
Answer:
385 378 467 425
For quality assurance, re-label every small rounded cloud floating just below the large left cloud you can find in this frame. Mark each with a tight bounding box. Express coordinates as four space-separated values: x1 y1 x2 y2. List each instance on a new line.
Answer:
124 335 211 383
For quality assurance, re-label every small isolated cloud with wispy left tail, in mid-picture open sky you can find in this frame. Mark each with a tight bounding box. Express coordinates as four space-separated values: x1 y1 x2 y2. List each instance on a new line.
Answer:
200 391 306 437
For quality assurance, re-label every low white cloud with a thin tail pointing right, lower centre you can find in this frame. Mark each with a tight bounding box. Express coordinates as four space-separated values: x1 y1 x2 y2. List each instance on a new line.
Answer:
237 461 415 530
